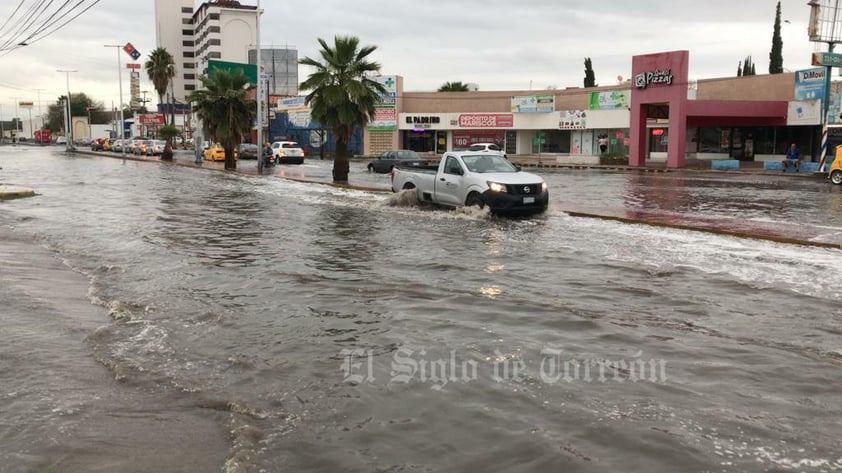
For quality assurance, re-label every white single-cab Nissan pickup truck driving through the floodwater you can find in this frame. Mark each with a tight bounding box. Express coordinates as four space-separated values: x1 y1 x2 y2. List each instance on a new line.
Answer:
392 151 550 213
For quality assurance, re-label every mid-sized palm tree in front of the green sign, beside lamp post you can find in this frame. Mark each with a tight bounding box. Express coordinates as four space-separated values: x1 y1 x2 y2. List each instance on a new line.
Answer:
187 69 257 169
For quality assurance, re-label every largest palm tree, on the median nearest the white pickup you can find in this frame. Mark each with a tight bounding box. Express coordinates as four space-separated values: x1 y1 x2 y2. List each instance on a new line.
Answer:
299 36 387 182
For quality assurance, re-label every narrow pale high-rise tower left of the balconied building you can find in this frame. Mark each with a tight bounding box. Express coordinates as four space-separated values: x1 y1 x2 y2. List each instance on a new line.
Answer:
155 0 198 103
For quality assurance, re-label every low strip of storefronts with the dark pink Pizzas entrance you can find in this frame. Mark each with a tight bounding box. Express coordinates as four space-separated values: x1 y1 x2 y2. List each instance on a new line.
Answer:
346 51 820 167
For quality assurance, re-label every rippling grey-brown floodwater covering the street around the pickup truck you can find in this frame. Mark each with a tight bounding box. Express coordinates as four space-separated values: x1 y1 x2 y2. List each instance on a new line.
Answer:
0 147 842 473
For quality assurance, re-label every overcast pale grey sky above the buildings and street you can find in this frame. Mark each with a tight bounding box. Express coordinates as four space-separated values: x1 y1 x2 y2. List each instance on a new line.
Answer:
0 0 827 120
